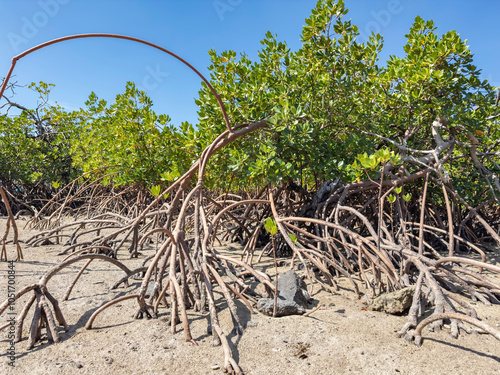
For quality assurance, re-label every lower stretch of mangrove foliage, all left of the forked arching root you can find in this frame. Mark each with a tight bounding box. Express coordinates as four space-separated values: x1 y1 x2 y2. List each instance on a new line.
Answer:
0 82 205 194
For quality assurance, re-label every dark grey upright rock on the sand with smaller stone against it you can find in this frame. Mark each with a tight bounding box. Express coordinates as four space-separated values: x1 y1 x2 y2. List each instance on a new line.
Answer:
257 270 310 317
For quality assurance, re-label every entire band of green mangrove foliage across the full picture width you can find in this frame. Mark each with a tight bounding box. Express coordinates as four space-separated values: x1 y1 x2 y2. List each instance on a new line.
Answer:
0 0 500 201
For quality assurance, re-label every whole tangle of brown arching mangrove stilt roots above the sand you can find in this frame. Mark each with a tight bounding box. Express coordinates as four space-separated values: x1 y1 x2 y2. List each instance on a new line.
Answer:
0 121 500 374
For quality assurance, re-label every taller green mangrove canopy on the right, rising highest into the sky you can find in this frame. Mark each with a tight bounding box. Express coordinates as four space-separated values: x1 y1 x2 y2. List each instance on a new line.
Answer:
196 0 500 194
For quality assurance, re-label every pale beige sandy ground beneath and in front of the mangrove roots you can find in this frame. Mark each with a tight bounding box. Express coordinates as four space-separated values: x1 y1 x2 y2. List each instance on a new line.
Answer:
0 219 500 375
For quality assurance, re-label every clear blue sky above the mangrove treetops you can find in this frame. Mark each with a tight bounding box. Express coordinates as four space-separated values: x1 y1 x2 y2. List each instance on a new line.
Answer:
0 0 500 124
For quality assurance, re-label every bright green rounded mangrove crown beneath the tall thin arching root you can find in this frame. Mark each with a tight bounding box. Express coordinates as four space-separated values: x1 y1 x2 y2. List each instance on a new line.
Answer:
68 83 195 188
